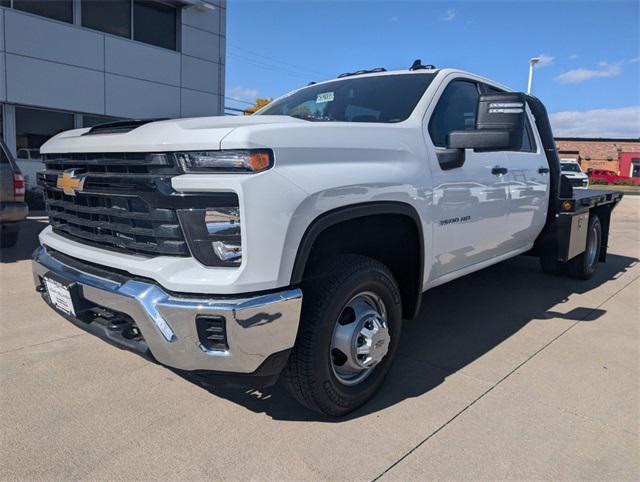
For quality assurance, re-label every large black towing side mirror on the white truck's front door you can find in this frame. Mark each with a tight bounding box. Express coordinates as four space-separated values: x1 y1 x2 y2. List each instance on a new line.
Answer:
447 92 526 152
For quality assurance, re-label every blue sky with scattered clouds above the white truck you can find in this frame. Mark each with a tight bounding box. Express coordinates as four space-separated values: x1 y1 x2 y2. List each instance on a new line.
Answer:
226 0 640 137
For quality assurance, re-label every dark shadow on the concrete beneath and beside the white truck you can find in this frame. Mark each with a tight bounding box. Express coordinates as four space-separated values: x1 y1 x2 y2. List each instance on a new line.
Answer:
190 254 638 422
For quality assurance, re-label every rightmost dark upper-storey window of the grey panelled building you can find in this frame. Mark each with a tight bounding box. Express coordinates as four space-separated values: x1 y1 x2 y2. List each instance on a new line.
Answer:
133 0 177 50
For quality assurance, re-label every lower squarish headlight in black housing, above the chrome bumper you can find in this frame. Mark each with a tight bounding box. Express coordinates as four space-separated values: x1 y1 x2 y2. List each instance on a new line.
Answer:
178 206 242 267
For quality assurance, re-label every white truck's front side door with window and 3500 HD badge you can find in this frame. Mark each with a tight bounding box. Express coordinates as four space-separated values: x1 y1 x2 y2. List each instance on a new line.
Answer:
425 78 508 280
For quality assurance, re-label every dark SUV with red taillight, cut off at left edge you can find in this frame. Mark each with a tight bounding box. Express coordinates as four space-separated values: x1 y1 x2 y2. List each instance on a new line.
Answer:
0 141 29 248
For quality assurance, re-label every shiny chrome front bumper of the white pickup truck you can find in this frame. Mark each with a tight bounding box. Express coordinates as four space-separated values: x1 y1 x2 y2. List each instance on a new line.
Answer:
33 247 302 374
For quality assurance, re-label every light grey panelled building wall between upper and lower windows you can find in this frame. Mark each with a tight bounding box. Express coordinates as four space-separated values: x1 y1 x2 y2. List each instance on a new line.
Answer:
0 0 226 121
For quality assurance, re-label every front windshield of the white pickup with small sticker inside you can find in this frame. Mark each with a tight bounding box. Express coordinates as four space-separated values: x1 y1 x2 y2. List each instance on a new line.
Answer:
256 73 435 123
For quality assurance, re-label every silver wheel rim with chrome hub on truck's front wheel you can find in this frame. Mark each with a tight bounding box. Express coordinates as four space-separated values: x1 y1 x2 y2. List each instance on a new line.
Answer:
331 292 391 385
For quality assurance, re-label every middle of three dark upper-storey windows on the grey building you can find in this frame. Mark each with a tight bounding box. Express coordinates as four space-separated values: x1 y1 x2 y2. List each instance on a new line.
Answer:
81 0 131 38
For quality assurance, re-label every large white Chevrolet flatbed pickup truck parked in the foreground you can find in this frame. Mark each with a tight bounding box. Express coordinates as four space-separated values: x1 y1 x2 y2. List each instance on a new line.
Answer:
33 61 622 416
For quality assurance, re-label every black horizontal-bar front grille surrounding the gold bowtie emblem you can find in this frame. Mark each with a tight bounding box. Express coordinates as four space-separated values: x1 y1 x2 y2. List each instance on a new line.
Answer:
39 153 189 256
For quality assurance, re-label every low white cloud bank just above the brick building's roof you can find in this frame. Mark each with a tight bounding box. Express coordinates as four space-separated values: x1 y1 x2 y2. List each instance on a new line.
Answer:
549 105 640 138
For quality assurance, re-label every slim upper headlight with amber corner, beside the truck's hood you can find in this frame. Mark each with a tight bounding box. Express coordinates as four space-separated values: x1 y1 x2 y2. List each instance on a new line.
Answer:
175 149 273 173
